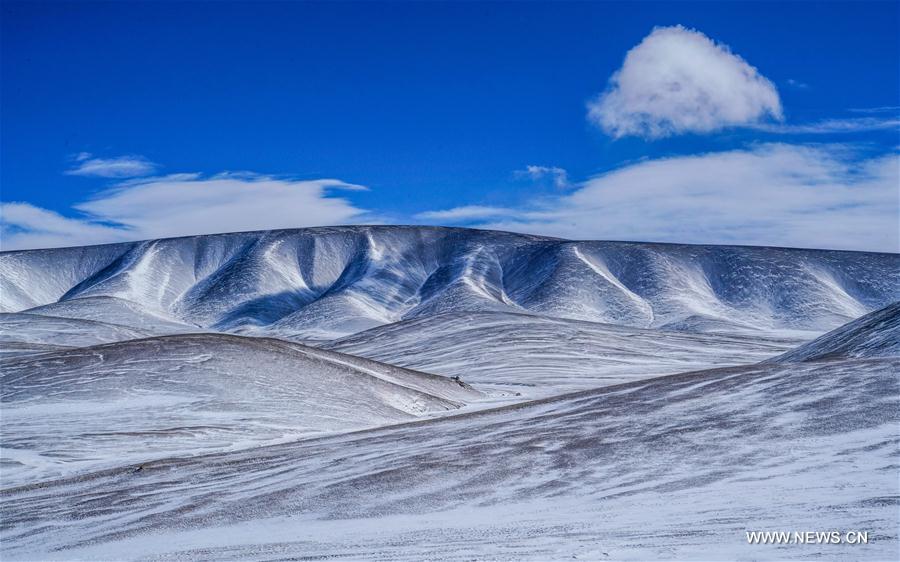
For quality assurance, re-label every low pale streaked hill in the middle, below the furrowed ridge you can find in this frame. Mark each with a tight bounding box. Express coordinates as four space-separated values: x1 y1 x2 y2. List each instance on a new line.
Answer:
325 312 799 398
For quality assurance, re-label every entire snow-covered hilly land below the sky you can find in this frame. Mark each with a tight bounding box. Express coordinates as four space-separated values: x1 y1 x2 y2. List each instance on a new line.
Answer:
0 227 900 560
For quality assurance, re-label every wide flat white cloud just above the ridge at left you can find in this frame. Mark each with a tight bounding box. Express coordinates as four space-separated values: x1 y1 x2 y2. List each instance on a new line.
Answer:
0 173 372 250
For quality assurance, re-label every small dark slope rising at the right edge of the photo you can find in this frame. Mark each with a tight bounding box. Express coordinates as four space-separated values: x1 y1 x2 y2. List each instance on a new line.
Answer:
771 302 900 363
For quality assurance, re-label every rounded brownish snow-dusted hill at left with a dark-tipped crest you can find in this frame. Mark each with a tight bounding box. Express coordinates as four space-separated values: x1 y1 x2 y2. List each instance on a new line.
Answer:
0 334 481 487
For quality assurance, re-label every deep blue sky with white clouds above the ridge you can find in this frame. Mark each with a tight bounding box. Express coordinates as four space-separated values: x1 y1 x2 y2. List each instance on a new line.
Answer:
0 1 900 251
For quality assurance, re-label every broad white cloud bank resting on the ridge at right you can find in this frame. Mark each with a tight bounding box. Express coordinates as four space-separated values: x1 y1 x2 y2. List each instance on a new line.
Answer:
422 144 900 252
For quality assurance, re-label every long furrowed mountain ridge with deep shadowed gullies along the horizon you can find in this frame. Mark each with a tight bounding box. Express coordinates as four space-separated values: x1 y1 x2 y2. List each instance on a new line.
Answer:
0 226 900 339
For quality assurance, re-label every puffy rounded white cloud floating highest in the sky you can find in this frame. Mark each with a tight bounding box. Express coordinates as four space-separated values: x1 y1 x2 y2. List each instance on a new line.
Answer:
589 26 782 138
